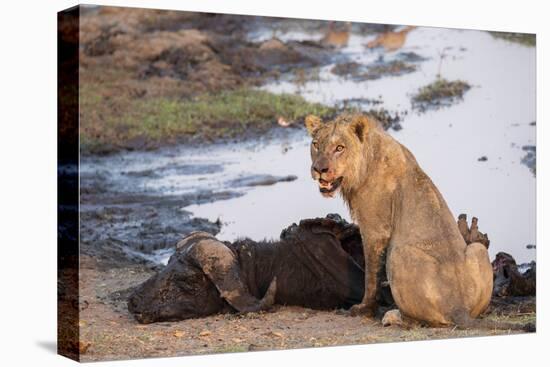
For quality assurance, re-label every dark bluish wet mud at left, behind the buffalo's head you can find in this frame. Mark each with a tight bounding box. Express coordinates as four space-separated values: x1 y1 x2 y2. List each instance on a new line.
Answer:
80 160 233 268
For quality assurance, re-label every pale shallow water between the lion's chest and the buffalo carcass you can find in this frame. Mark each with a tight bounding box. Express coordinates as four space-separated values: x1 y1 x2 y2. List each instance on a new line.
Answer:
185 130 349 241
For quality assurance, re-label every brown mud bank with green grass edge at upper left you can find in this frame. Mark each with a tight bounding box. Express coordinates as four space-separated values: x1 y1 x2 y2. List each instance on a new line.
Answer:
80 7 354 154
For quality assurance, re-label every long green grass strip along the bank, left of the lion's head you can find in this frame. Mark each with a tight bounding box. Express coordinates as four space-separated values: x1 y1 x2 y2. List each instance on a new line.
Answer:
80 89 336 153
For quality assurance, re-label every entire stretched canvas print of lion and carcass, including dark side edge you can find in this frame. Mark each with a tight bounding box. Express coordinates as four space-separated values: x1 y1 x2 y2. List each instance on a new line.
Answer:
58 5 536 361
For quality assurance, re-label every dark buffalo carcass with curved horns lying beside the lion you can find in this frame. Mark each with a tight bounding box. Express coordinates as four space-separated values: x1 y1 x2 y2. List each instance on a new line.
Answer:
128 215 380 323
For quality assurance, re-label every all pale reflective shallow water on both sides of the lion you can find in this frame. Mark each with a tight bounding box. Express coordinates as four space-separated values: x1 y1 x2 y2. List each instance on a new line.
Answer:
186 28 536 262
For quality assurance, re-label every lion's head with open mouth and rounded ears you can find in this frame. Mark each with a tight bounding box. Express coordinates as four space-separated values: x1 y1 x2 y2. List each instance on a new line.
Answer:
305 115 374 197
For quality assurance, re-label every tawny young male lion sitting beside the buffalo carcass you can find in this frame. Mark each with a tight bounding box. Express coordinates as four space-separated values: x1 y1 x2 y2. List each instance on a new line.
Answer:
305 115 493 326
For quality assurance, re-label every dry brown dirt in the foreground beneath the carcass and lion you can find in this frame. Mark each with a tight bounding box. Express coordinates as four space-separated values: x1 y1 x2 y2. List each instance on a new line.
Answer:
79 255 535 361
